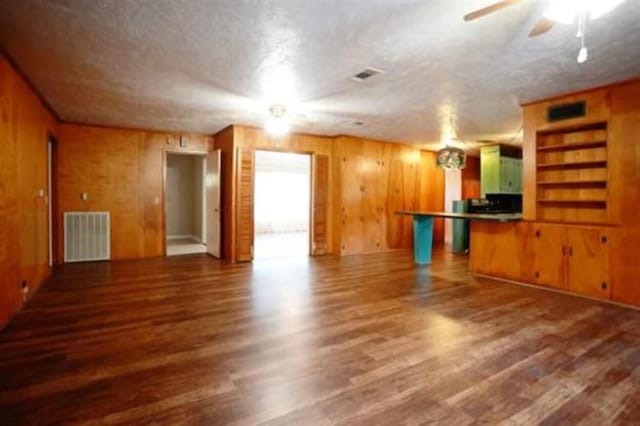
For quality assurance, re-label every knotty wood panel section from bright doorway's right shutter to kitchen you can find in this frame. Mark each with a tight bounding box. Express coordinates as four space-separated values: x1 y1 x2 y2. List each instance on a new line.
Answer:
333 136 444 254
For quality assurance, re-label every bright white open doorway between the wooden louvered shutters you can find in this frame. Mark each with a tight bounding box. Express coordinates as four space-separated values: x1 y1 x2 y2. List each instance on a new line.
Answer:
253 151 311 259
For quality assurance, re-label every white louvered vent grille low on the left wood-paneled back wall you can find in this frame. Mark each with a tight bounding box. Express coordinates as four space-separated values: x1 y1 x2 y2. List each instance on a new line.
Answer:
63 212 111 262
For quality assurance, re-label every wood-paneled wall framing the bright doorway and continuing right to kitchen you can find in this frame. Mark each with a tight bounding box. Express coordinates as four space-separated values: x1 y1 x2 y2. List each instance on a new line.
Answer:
215 126 444 261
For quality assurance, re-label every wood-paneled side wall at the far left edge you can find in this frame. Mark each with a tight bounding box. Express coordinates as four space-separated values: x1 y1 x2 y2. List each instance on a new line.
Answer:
0 55 56 328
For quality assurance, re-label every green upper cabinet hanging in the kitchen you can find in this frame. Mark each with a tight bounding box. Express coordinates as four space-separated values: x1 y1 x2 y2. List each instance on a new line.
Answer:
480 145 522 198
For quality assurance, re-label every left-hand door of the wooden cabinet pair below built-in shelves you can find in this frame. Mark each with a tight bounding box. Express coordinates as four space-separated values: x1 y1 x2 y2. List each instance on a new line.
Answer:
534 224 567 289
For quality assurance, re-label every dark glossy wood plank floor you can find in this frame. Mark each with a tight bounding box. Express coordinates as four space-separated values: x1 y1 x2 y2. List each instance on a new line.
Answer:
0 249 640 425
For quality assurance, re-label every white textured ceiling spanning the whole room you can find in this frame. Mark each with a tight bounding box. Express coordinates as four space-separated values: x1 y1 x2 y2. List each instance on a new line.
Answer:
0 0 640 147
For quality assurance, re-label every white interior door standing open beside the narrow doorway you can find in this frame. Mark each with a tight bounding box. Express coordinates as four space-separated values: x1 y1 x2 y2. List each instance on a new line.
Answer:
206 149 220 258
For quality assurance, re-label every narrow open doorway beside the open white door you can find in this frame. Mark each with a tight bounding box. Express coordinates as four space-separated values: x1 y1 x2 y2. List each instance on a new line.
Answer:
166 153 207 256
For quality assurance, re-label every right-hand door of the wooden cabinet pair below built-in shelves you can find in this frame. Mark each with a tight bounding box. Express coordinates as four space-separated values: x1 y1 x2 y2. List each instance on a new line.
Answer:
567 228 610 299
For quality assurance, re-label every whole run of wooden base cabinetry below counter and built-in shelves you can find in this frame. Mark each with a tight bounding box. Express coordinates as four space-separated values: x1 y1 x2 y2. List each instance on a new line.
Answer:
469 221 612 299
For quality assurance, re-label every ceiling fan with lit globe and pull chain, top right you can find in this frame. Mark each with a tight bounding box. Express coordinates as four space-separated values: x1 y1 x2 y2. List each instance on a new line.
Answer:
464 0 624 63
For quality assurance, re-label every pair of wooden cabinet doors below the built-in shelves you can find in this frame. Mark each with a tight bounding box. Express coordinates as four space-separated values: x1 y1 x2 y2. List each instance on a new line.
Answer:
533 224 610 299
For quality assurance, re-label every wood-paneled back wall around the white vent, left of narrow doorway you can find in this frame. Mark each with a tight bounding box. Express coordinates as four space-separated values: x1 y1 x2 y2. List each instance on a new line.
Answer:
55 124 213 262
